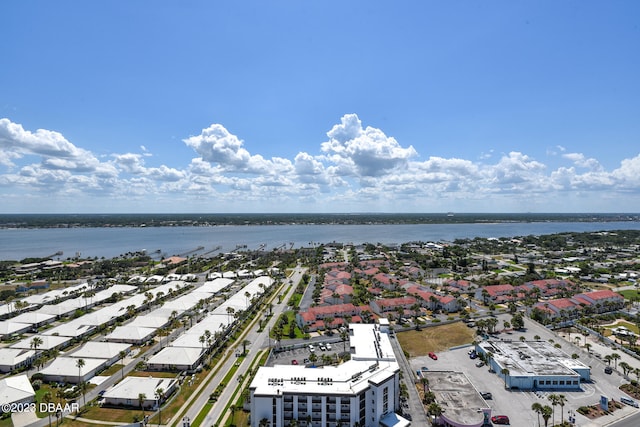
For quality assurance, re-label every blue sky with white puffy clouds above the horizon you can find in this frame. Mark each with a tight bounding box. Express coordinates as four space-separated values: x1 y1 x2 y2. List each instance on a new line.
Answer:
0 0 640 213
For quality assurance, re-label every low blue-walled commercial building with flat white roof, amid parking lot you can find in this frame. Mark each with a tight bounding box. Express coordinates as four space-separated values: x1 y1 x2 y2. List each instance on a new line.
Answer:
476 341 591 390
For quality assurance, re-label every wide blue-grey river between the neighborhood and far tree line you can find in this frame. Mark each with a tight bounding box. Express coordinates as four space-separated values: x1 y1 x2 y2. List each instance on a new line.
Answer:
0 221 640 260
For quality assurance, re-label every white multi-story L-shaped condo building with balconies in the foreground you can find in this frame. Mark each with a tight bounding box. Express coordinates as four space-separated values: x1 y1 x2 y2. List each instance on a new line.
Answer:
250 324 400 427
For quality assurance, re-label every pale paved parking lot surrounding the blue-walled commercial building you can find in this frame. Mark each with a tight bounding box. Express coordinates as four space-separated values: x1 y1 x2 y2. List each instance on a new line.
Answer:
410 315 637 426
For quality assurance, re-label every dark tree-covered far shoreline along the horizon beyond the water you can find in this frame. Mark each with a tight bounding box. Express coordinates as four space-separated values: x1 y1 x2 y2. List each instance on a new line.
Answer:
0 212 640 229
